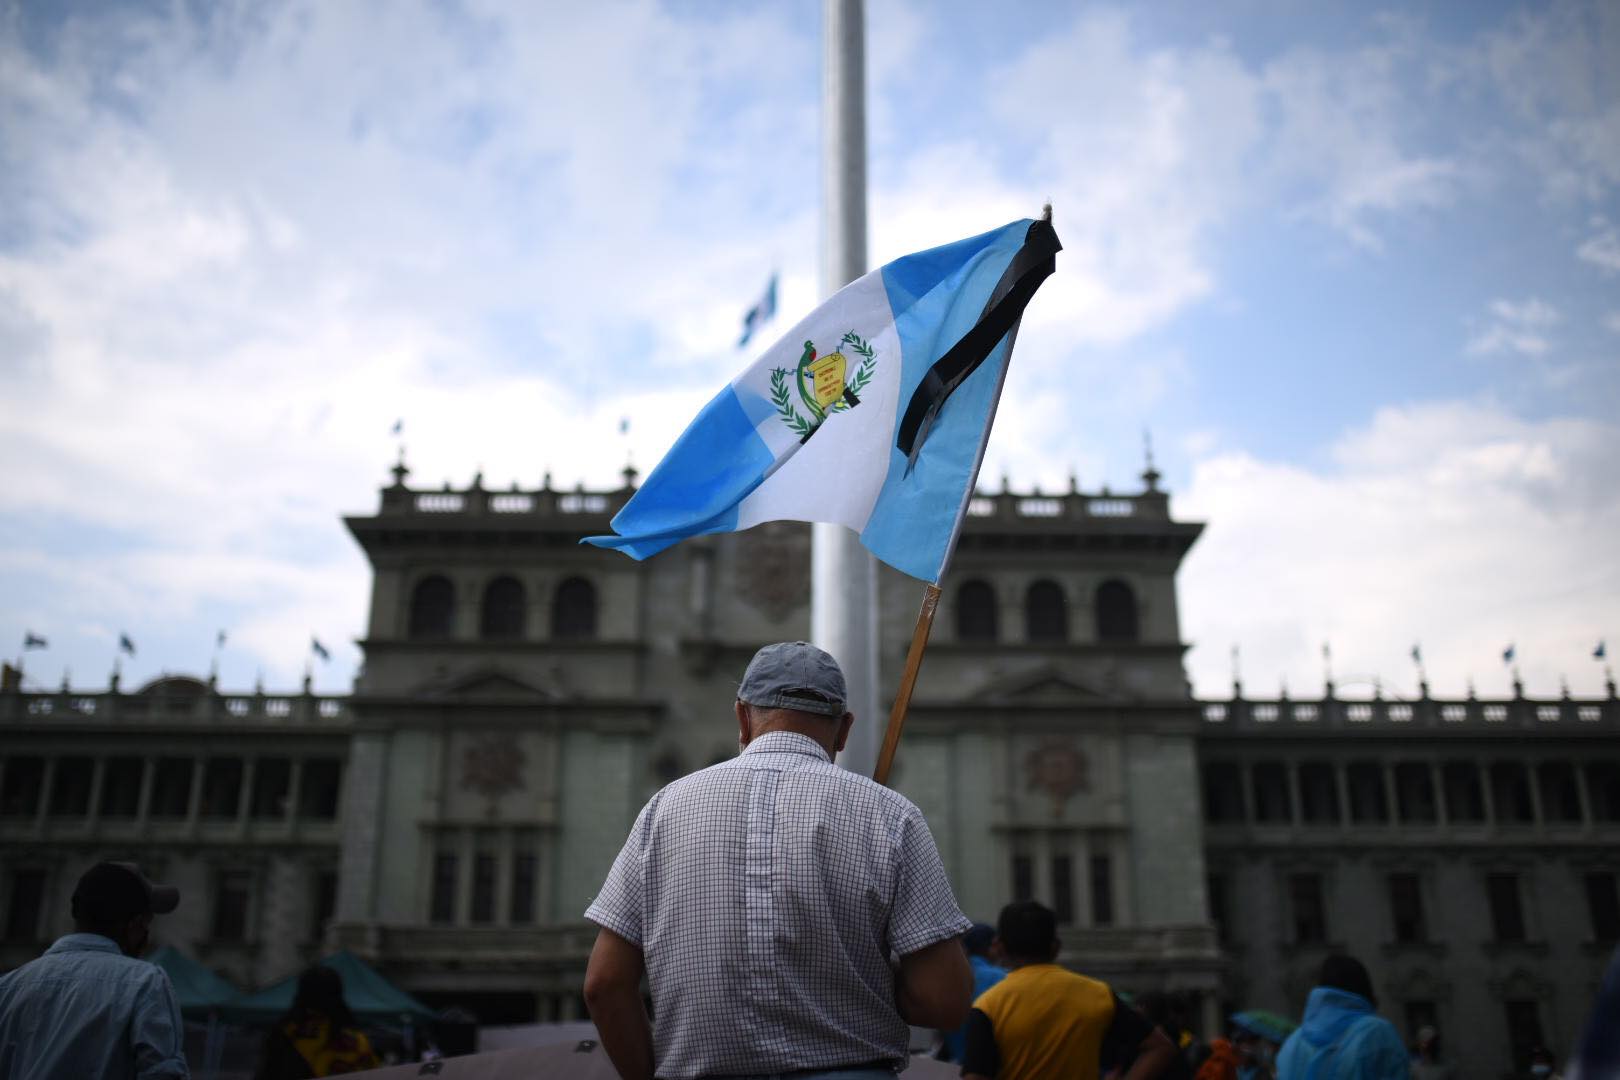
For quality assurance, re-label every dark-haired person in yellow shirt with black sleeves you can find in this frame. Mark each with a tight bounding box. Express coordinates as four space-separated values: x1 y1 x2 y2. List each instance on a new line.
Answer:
962 900 1176 1080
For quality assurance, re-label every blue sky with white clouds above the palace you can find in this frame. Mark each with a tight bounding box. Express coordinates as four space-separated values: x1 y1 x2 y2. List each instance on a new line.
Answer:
0 0 1620 695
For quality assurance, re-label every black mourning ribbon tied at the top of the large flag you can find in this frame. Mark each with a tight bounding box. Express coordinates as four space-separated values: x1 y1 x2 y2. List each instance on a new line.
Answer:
894 220 1063 474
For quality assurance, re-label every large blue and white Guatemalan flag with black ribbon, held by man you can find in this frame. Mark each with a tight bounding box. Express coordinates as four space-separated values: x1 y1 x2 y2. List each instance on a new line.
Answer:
586 220 1061 583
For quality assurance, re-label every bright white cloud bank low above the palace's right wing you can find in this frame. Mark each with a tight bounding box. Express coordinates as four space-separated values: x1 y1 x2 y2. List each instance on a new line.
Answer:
1176 403 1620 696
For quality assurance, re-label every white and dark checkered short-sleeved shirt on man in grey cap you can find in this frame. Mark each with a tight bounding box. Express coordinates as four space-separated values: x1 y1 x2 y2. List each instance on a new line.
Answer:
585 732 970 1078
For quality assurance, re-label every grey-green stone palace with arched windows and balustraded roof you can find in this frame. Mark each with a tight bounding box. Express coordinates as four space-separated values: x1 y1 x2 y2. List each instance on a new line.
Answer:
0 466 1620 1075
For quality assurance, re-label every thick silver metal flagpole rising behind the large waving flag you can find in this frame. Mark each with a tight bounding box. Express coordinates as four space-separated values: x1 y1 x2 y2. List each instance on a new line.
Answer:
810 0 880 776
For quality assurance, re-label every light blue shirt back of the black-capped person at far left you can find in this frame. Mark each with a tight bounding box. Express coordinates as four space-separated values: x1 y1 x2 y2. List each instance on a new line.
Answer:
0 934 190 1080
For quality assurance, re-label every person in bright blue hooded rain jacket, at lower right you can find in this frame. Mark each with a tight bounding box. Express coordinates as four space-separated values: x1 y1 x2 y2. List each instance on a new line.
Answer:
1277 955 1411 1080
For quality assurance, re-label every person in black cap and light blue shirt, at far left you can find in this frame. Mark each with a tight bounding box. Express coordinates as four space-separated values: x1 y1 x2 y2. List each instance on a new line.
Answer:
0 863 191 1080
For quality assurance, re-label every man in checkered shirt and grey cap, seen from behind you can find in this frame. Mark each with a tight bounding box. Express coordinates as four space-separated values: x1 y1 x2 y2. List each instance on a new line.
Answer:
585 641 972 1080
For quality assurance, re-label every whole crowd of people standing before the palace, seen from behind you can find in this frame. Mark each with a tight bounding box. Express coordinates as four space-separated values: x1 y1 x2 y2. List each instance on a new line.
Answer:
0 641 1620 1080
